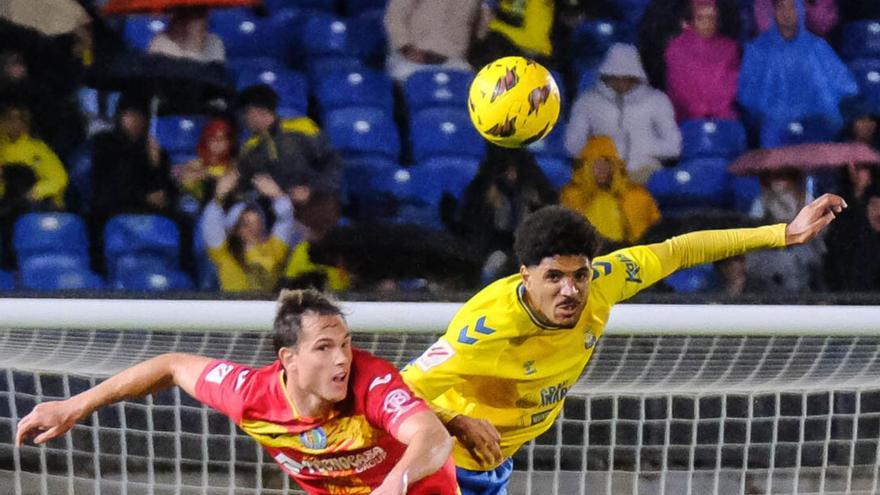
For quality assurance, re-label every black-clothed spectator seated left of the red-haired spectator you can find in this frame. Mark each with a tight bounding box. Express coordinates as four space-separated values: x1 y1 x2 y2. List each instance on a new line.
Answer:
92 94 174 230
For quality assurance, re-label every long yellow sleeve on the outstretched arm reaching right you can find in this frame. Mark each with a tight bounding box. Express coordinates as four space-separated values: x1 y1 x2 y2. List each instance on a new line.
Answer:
593 224 785 304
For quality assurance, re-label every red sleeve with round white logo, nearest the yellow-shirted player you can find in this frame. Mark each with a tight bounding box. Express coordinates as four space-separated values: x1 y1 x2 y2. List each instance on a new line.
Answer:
358 359 429 436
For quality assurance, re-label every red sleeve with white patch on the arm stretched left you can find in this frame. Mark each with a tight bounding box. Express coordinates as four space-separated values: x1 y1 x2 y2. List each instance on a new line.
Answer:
195 359 254 424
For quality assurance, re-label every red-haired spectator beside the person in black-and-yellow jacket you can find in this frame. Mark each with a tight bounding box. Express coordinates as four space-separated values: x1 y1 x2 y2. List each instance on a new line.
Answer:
174 118 236 203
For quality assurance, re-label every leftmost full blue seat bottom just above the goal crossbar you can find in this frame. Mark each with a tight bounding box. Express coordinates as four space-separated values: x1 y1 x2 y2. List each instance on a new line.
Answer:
19 255 104 291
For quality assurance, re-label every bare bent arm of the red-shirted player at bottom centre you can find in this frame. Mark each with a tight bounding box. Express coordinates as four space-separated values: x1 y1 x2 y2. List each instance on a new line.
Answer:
372 411 452 495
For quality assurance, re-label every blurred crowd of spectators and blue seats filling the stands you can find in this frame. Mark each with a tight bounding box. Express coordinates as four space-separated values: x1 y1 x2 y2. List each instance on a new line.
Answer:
0 0 880 296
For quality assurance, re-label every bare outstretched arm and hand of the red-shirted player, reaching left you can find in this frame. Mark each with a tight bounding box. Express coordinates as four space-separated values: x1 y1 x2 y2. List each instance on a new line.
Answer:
15 354 211 446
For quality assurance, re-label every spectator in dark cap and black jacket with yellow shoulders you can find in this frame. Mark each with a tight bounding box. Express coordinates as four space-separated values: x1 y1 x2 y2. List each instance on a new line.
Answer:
238 85 342 244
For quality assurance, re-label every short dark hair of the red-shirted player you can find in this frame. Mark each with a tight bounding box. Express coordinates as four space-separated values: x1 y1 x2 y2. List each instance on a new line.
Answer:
272 289 345 354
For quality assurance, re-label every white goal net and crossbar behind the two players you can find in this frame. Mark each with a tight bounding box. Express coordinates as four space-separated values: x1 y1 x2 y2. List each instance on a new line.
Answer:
0 301 880 495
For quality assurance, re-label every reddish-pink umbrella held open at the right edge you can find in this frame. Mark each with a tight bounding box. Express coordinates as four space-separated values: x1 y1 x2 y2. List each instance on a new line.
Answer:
728 143 880 175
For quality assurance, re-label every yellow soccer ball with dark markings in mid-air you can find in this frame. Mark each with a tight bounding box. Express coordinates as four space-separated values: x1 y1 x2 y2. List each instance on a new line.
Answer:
468 57 559 148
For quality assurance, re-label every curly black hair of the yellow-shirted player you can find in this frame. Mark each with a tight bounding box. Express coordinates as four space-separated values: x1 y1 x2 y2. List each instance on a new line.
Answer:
513 206 601 266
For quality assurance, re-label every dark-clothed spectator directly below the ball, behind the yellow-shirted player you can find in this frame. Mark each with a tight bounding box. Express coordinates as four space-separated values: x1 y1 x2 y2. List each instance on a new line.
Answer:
459 145 556 279
